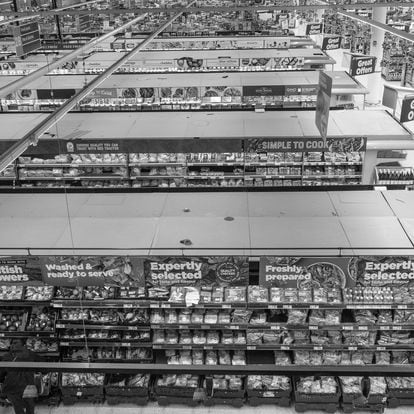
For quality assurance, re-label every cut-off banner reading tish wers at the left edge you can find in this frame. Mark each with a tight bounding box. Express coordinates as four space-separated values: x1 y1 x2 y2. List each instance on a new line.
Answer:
0 256 42 285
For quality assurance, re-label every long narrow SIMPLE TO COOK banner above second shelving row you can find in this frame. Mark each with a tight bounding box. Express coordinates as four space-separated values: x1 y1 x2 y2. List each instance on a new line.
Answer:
245 137 367 152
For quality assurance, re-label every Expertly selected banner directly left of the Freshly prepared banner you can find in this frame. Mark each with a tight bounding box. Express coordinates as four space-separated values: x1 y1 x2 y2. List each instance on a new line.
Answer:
144 256 249 287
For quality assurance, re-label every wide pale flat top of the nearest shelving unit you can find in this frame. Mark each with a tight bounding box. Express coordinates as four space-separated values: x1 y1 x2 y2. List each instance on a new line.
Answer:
0 191 414 256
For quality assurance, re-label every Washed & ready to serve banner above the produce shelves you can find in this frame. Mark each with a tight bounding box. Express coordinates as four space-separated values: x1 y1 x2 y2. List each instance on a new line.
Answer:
40 256 145 286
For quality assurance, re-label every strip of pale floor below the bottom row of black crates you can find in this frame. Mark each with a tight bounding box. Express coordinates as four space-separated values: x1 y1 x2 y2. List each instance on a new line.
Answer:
0 403 414 414
